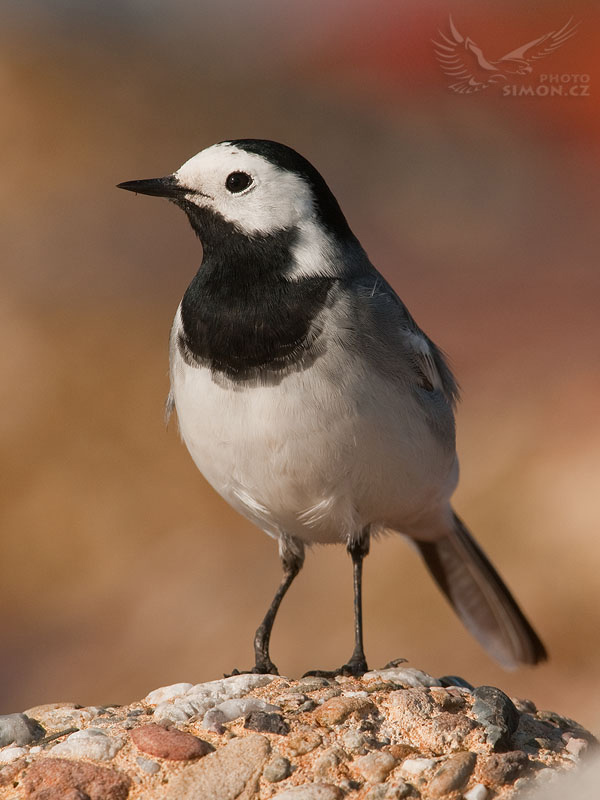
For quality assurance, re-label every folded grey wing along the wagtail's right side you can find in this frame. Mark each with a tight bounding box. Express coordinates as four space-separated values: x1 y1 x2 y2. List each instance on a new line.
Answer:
353 276 459 408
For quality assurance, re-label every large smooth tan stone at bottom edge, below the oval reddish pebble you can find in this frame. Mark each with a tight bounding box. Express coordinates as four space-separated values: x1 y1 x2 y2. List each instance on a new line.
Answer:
152 734 270 800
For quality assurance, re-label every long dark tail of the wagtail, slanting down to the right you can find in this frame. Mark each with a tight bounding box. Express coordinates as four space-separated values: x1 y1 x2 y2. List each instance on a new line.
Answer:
416 514 548 669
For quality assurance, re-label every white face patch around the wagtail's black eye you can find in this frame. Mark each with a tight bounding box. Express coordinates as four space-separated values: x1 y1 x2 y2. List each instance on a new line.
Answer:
175 142 315 234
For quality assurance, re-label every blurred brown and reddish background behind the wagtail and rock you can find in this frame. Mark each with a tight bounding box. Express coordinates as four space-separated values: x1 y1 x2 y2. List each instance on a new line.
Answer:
0 0 600 732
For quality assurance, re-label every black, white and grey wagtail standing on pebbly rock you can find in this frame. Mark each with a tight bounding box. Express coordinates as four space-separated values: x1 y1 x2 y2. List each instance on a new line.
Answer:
119 139 546 675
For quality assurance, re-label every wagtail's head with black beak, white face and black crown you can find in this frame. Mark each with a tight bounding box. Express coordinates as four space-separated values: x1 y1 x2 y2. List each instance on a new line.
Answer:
119 139 352 250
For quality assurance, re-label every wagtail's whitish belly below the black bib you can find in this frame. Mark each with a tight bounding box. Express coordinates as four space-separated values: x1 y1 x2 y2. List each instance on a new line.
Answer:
171 322 456 543
